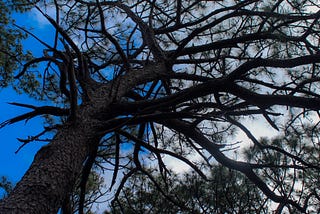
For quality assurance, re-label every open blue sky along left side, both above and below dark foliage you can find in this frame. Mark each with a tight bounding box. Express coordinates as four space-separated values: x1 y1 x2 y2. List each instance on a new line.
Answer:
0 7 54 193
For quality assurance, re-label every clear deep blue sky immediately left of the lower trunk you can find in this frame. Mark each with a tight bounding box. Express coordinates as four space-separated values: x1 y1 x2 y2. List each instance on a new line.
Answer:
0 88 43 182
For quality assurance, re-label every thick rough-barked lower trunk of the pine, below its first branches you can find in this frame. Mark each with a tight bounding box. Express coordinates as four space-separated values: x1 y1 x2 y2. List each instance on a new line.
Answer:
0 119 99 214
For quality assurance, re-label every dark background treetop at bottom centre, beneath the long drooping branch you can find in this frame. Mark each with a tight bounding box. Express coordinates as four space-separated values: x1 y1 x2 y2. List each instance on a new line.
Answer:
105 165 270 214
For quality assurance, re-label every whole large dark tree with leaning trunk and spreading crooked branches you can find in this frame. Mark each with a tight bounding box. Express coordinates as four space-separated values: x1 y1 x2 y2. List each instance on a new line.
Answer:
0 0 320 213
